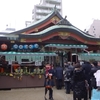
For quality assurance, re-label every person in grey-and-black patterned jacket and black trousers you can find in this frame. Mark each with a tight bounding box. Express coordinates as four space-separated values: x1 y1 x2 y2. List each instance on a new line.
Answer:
63 62 73 94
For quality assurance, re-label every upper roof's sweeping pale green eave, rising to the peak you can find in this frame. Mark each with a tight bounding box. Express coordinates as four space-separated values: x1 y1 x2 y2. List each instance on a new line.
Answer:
9 9 63 34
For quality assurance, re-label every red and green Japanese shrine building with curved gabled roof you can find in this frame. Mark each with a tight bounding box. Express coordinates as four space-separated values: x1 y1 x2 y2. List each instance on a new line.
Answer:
0 7 100 89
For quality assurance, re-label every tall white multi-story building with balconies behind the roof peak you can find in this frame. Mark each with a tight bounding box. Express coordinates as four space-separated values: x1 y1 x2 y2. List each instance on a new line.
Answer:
32 0 62 22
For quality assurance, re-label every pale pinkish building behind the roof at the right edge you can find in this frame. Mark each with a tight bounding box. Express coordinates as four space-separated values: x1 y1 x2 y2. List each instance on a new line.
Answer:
88 19 100 38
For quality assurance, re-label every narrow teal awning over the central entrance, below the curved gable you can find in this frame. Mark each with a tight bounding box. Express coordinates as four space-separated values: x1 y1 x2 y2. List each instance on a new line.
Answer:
45 44 88 49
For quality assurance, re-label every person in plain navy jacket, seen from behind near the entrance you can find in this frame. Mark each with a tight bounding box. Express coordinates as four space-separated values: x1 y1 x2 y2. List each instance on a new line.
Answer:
55 64 63 89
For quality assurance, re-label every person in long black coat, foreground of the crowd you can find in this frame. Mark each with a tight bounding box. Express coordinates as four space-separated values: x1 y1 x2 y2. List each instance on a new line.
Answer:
72 63 88 100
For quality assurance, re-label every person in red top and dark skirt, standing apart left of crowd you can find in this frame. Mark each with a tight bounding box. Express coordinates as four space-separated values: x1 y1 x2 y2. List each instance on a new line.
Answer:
44 64 54 100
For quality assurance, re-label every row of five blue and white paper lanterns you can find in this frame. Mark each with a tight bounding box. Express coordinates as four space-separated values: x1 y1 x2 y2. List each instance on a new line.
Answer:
13 44 39 50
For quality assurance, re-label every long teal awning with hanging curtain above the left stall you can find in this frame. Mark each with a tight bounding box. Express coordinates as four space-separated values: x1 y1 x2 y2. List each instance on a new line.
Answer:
0 52 57 63
